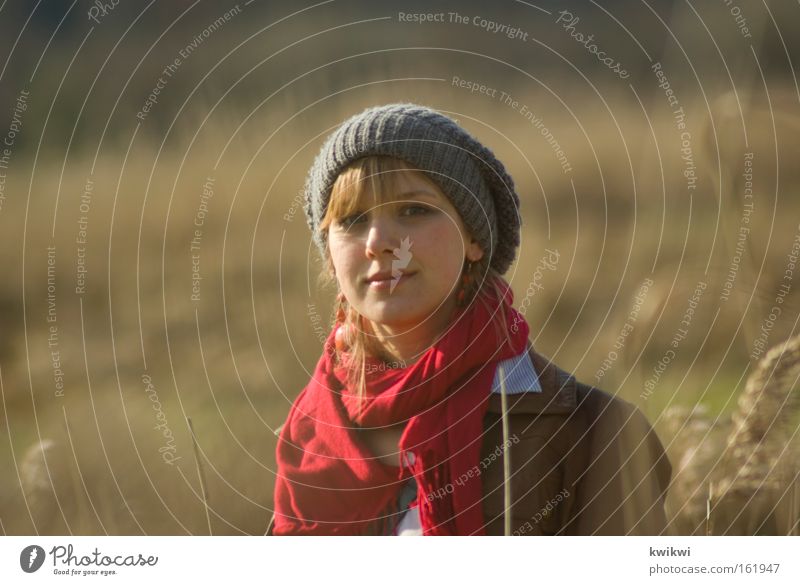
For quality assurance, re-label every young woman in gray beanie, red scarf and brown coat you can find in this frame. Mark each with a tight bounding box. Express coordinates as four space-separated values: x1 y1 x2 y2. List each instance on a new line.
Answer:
268 104 671 535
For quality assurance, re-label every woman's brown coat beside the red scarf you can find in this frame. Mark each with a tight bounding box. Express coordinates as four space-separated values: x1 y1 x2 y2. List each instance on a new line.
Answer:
267 347 672 535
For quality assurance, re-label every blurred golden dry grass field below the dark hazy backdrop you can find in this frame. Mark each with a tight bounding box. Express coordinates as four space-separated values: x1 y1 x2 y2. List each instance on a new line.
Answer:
0 1 800 535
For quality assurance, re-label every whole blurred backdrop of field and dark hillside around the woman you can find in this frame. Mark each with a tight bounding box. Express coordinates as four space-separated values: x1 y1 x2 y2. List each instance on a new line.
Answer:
0 0 800 534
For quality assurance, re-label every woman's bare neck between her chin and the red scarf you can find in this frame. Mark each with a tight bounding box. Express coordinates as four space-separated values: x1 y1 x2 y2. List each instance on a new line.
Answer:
371 298 456 367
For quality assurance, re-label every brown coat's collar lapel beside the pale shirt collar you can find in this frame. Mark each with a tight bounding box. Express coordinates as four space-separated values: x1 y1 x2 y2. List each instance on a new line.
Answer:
489 342 577 414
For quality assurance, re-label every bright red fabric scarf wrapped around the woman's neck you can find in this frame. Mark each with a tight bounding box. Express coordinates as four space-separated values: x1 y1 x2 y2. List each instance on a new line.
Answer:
273 287 528 535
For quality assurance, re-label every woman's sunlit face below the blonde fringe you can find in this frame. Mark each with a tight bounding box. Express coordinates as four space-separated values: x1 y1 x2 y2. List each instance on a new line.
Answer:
328 170 483 330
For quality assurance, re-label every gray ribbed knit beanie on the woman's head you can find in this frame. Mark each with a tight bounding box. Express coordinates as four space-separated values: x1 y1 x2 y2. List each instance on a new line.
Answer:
305 103 520 274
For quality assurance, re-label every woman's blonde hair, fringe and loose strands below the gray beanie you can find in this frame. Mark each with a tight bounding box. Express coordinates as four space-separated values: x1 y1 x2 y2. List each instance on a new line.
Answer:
318 156 510 406
